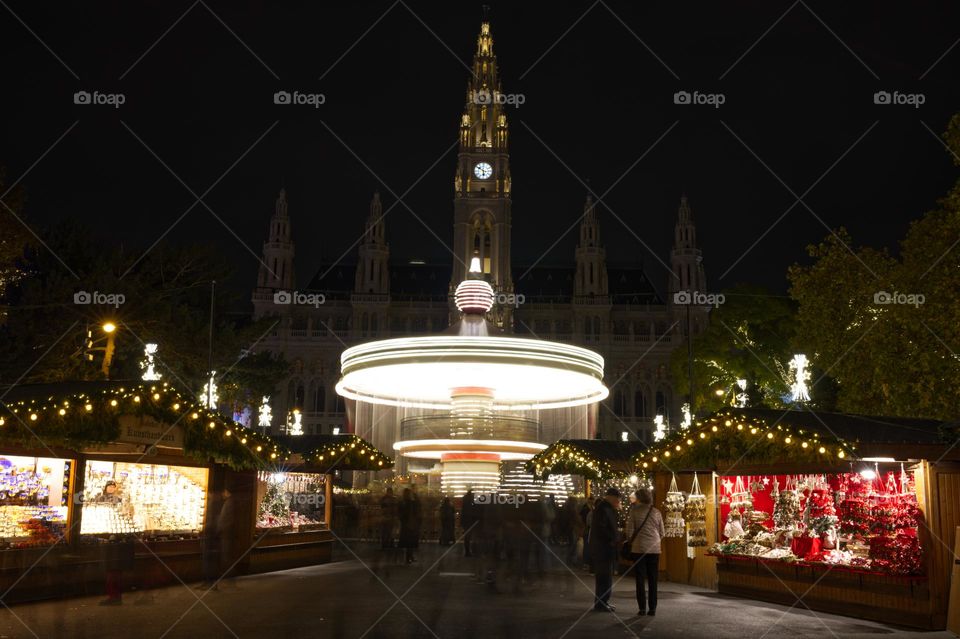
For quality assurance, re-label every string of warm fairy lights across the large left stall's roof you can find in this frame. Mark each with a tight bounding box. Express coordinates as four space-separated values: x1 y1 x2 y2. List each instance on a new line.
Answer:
0 382 290 462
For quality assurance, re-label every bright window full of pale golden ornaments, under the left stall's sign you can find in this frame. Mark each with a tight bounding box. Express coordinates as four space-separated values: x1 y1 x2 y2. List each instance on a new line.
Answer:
80 460 207 537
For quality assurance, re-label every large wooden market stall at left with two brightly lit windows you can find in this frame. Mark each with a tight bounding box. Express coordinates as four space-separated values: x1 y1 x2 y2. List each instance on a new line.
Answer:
0 382 289 600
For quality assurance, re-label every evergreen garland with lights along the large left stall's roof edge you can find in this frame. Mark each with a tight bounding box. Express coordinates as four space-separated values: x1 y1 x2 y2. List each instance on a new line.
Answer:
0 383 290 470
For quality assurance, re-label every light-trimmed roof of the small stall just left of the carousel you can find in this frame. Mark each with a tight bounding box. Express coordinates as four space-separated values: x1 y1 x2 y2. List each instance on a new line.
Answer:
277 433 393 473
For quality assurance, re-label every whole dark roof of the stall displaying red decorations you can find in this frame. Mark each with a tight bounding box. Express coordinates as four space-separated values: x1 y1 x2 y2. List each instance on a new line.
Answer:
634 408 960 471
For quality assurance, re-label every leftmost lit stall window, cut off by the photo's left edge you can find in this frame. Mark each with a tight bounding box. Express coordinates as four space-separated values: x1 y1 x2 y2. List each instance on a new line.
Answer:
0 455 73 548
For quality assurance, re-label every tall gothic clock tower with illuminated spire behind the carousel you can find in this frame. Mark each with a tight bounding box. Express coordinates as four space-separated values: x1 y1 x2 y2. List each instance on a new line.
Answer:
450 19 513 312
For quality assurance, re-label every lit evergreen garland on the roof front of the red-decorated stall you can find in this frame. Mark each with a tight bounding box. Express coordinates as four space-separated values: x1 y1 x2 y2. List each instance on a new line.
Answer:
633 411 855 470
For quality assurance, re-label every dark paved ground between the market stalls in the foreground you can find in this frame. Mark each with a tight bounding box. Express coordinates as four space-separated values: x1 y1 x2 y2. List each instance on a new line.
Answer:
0 546 953 639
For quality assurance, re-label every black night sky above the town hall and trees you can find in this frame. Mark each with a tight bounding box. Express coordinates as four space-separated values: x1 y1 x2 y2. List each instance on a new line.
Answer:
0 1 960 302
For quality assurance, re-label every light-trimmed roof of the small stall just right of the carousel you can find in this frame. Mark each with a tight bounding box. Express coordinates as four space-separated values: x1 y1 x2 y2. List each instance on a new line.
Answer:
527 439 647 479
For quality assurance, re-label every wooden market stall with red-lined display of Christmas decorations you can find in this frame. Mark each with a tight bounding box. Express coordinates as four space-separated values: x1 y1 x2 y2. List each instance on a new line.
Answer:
635 409 960 628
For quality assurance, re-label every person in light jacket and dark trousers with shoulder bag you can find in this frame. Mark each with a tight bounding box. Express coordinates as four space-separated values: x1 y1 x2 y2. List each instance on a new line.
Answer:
627 488 665 617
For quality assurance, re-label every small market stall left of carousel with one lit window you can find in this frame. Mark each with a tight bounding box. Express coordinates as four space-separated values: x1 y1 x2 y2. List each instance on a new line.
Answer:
244 434 393 573
